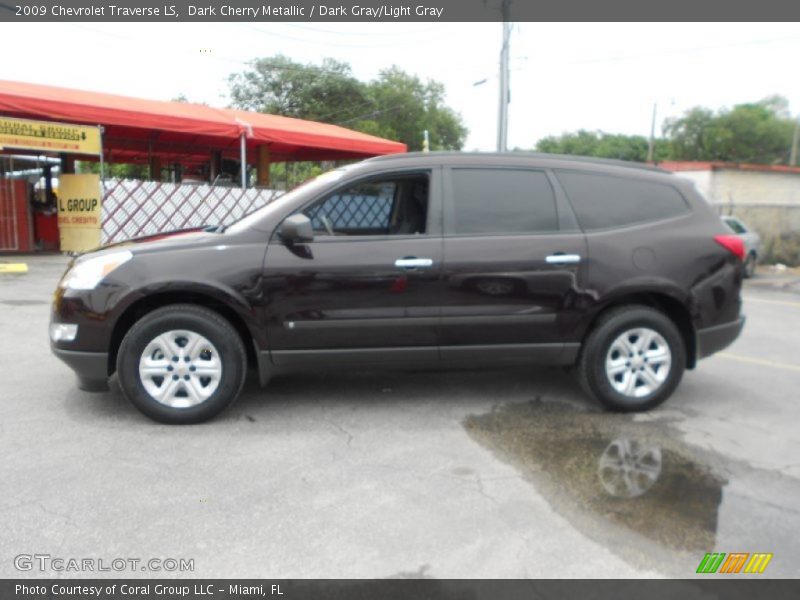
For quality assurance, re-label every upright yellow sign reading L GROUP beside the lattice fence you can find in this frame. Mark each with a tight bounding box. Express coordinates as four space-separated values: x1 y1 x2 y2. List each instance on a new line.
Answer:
58 174 103 252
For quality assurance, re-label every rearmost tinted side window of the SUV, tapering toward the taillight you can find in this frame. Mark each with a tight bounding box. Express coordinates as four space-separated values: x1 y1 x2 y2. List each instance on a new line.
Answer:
556 171 689 230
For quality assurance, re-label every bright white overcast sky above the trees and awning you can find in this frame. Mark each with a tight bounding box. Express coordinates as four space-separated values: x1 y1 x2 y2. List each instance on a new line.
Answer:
0 22 800 150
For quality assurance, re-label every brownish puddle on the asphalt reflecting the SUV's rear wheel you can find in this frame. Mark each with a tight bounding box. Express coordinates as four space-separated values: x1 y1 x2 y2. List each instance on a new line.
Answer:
465 399 727 574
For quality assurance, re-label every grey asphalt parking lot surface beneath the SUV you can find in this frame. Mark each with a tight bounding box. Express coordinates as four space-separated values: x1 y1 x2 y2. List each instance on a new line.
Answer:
0 256 800 578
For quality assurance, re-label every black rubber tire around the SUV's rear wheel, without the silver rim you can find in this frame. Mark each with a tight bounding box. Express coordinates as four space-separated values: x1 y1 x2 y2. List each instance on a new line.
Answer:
578 305 686 412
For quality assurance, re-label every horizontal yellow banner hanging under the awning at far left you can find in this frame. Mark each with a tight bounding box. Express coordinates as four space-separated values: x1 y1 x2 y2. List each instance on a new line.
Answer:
0 117 102 156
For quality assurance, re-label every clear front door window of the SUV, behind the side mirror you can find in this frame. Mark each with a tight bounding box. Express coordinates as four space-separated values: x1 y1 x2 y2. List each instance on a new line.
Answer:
303 174 430 236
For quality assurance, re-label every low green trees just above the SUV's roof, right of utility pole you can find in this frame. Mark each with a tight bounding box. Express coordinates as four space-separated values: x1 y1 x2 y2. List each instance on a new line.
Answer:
536 129 668 162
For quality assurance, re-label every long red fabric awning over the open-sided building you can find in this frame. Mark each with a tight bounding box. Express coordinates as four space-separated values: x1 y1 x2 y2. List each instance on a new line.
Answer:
0 80 406 162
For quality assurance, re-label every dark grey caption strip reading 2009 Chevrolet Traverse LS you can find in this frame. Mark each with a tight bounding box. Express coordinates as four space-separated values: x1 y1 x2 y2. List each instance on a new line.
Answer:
0 0 800 23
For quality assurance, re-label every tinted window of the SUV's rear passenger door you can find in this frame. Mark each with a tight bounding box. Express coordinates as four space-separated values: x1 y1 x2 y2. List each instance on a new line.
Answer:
448 169 558 235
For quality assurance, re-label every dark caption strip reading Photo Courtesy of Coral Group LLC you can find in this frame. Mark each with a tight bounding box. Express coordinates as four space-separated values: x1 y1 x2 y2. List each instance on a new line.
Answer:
0 579 800 600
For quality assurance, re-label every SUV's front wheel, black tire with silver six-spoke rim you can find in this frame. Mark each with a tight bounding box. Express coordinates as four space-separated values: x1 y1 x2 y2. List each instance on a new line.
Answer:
117 304 247 424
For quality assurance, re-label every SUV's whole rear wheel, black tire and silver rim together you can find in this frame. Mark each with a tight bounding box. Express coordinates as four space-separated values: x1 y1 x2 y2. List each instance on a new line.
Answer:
579 306 686 412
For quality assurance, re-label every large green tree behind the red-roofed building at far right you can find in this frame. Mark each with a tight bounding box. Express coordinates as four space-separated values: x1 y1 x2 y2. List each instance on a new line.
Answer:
664 96 794 164
